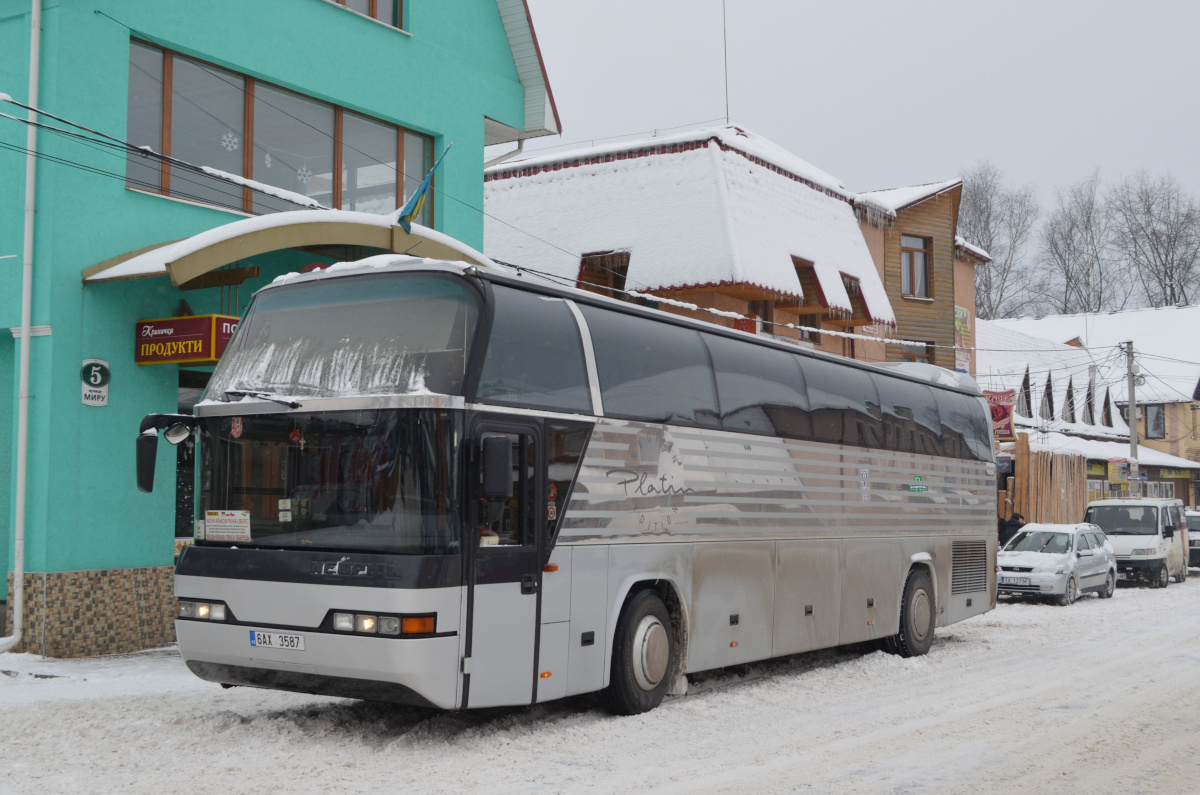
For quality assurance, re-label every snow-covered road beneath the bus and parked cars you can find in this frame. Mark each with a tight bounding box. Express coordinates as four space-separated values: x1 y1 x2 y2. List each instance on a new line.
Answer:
0 579 1200 795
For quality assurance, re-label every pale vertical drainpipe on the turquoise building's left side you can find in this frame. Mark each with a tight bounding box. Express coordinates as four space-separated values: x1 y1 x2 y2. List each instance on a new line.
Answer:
0 0 42 652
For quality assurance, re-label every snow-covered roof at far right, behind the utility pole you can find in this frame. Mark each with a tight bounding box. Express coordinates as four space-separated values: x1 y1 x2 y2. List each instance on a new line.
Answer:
994 306 1200 404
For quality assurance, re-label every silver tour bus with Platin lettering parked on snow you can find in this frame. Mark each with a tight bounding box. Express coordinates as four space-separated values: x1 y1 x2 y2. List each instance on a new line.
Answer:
137 257 996 715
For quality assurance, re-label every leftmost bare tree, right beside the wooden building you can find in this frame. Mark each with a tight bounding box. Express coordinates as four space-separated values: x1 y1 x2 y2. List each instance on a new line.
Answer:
958 161 1040 319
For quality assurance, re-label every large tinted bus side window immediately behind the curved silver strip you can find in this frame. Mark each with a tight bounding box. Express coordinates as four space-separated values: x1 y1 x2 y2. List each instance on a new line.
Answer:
580 304 720 428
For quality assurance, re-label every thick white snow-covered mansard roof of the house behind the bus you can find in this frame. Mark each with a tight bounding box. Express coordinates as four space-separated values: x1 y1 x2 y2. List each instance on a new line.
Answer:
484 126 895 324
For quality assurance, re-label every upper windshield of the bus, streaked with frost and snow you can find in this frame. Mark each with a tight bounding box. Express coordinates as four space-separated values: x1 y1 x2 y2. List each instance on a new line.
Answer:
208 273 479 401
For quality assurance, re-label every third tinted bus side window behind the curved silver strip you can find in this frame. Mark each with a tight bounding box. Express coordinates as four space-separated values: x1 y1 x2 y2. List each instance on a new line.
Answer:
796 355 883 448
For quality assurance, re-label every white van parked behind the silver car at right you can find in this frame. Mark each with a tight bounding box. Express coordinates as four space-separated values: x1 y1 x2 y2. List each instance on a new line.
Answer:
1084 500 1188 588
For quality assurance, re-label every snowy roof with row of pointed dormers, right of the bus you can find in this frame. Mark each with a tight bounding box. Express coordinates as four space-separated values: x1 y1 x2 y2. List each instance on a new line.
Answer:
976 319 1129 440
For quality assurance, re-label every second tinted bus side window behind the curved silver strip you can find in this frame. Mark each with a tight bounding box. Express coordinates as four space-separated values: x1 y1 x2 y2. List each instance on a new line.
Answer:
703 334 812 440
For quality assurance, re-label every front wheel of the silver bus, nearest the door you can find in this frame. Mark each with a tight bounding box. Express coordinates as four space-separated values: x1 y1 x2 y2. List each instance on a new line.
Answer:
602 590 676 715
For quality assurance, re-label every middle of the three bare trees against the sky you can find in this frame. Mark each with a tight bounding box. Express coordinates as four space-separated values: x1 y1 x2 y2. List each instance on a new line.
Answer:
1038 171 1133 315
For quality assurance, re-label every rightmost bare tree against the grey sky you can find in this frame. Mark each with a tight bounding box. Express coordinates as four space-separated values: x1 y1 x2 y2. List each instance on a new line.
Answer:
1110 172 1200 306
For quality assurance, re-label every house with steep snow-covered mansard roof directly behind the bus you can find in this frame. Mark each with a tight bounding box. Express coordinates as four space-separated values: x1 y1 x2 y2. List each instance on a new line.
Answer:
484 126 895 359
